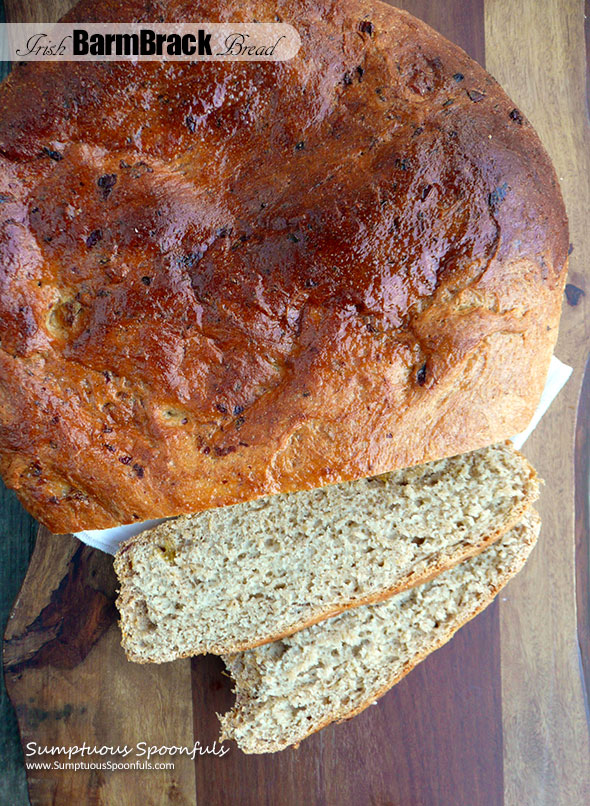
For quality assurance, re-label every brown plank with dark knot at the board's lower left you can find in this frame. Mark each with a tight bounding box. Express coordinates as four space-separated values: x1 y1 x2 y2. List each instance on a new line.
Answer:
4 528 195 806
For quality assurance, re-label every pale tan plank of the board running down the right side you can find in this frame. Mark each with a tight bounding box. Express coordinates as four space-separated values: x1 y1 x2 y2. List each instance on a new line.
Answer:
485 0 590 806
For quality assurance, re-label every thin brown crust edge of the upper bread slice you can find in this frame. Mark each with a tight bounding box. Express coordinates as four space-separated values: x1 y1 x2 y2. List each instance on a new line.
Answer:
114 448 538 663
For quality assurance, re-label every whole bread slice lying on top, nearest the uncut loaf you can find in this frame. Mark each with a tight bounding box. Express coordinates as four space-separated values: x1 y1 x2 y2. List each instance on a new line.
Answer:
115 445 538 662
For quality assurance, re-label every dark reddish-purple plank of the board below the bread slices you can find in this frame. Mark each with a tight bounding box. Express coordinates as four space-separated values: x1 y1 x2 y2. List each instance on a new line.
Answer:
193 608 504 806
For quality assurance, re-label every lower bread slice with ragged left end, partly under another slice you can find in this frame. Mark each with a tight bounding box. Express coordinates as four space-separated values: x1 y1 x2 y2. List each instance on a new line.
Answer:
220 510 540 753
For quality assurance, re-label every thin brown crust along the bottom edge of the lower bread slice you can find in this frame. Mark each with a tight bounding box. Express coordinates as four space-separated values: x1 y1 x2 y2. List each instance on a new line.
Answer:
219 510 541 753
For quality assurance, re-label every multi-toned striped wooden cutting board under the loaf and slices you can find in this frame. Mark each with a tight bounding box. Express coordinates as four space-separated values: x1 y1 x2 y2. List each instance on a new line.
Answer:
4 0 590 806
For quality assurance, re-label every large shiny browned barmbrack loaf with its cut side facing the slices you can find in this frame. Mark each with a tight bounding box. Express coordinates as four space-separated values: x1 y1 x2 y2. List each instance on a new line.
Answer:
0 0 568 532
